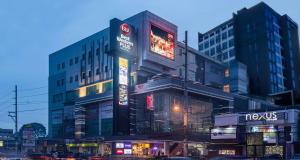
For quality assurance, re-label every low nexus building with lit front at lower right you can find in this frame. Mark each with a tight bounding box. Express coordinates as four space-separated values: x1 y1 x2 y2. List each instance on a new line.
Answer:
209 109 300 159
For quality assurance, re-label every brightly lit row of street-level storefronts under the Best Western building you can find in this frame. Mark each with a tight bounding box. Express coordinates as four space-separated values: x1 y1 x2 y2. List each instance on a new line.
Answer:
66 134 209 157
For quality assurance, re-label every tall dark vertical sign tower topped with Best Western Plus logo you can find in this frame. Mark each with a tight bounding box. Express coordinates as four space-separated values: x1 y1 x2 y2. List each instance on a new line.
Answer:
109 18 137 136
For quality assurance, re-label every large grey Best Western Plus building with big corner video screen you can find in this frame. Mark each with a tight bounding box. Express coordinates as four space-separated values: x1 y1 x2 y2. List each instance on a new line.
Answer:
49 11 275 156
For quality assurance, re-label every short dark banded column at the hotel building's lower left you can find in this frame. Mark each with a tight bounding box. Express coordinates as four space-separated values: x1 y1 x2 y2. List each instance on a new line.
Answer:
74 106 86 139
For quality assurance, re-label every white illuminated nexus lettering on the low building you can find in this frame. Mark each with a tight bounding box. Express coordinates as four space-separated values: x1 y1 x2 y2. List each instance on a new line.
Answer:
246 112 277 121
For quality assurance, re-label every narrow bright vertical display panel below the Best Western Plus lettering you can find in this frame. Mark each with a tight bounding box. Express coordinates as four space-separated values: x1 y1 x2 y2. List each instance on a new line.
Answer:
119 57 128 105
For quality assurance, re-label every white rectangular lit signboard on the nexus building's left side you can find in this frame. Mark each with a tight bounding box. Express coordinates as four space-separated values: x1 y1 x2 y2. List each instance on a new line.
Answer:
211 127 236 139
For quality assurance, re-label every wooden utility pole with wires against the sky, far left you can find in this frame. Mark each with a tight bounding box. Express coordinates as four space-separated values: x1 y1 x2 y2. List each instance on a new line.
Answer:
8 85 19 153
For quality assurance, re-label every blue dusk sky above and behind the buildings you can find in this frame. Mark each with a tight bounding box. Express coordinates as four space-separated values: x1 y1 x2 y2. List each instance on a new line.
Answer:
0 0 300 132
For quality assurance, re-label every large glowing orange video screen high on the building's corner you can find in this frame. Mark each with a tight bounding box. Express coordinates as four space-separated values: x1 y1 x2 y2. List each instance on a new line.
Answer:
150 24 175 60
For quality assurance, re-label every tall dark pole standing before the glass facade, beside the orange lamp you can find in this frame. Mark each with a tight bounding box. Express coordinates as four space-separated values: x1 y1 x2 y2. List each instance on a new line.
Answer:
183 31 189 157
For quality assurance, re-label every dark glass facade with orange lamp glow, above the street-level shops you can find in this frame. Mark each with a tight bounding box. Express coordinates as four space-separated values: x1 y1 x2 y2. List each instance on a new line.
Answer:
136 92 213 134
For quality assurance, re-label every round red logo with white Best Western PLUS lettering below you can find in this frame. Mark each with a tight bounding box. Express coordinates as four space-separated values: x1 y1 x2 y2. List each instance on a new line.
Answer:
117 23 133 52
